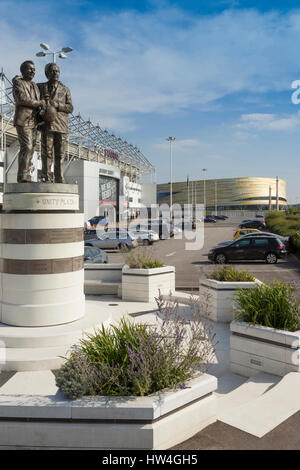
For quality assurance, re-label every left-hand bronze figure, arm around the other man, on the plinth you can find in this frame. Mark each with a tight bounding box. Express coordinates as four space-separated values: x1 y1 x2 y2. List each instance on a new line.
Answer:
13 60 45 183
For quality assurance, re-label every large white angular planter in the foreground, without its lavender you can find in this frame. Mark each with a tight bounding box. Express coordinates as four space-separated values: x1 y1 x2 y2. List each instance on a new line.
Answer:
0 374 217 450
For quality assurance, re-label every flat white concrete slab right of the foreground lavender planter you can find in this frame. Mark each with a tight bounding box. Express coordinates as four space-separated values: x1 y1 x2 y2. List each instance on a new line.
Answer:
218 372 300 437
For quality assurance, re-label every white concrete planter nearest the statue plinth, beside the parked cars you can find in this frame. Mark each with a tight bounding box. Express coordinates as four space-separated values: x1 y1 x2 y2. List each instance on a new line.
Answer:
122 265 175 302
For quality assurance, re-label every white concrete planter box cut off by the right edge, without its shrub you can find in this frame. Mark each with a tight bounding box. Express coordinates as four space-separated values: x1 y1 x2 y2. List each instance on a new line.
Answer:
230 321 300 377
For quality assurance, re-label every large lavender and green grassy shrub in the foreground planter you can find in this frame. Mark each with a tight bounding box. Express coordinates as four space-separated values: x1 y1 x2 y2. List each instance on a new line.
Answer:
55 296 214 399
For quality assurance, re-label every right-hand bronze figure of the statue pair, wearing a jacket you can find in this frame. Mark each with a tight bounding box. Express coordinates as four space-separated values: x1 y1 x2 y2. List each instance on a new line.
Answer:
38 63 73 183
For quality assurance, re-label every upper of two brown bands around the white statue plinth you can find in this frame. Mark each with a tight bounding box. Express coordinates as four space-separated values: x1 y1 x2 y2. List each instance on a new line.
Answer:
0 227 84 245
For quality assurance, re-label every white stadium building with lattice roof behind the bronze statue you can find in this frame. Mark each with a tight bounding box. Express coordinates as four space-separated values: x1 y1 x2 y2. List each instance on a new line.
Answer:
0 71 156 221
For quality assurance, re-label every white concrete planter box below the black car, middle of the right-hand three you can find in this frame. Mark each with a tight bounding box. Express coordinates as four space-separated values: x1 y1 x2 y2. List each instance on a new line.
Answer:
199 279 262 323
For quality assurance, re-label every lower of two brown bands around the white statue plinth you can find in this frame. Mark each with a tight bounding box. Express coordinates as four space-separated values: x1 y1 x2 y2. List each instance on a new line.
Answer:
0 256 84 275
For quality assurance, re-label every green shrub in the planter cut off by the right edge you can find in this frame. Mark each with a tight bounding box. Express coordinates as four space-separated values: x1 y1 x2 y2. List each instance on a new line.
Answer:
235 281 300 331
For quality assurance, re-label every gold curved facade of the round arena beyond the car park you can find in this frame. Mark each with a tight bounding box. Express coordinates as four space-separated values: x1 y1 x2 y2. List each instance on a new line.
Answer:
157 177 287 211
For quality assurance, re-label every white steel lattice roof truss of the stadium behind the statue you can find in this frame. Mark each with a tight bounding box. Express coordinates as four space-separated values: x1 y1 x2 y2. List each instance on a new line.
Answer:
0 70 155 178
